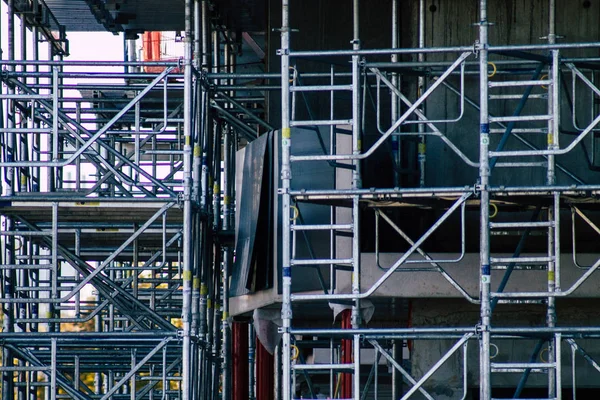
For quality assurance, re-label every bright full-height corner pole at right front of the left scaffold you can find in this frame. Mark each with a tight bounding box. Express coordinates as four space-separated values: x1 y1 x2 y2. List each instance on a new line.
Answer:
181 0 193 400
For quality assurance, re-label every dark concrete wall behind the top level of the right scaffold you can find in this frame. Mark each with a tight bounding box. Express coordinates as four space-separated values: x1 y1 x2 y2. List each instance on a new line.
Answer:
268 0 600 187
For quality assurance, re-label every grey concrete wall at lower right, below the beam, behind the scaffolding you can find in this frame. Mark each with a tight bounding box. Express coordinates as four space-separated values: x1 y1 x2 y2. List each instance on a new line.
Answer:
410 298 600 399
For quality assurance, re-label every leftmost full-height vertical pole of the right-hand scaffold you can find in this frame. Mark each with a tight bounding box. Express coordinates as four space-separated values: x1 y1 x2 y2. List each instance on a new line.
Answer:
280 0 292 400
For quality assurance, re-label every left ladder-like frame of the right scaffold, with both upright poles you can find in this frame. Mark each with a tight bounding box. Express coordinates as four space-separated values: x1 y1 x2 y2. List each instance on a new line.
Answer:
280 0 361 400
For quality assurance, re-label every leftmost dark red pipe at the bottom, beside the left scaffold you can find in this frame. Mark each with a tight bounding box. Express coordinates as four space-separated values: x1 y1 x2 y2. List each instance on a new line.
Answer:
231 322 250 400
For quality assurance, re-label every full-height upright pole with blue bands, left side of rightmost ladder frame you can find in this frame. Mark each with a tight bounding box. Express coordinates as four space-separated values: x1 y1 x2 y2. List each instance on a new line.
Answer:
479 0 492 400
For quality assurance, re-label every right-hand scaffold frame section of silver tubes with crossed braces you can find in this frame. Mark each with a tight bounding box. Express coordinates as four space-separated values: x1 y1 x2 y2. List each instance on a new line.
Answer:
279 0 600 400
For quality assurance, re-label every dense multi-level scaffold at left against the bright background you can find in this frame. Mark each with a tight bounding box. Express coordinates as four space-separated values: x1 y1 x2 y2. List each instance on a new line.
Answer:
0 0 271 400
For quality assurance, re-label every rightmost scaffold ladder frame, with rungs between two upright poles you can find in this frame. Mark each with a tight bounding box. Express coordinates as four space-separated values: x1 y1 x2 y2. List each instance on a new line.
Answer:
480 2 562 400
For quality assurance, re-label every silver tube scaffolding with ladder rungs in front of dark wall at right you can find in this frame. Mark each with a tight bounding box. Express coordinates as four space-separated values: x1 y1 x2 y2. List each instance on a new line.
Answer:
279 0 600 400
